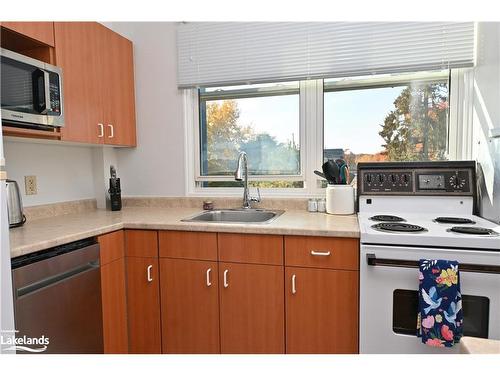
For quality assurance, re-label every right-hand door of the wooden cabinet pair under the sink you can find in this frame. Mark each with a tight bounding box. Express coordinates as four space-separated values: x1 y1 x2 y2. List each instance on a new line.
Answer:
219 263 285 354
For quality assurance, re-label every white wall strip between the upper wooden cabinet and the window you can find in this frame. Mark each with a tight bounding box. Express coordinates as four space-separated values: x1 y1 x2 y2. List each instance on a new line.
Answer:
104 22 185 196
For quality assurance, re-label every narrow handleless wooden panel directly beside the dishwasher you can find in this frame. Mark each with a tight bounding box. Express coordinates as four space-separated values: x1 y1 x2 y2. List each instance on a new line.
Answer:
99 231 128 354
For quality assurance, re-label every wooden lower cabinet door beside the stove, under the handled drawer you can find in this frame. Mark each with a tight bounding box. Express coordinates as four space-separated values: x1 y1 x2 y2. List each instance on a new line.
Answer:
285 267 358 354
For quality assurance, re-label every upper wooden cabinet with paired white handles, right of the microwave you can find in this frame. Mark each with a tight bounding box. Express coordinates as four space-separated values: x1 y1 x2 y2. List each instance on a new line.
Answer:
54 22 136 146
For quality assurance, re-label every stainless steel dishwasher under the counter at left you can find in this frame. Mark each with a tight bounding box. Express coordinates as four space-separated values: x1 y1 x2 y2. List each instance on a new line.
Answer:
12 239 103 353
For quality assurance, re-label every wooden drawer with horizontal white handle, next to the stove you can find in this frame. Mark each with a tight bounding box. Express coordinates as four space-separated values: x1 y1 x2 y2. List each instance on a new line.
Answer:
285 236 359 270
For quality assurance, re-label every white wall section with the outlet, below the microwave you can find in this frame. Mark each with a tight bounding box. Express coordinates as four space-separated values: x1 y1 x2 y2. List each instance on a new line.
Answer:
4 140 95 207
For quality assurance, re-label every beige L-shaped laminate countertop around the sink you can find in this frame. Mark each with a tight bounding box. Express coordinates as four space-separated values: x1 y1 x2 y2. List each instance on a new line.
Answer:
9 207 359 258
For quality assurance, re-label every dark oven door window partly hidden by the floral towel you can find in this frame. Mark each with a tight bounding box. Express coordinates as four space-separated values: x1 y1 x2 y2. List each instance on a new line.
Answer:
392 289 490 338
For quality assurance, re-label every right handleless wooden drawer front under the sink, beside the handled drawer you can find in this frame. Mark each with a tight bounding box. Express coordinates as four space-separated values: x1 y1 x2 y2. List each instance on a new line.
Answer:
218 233 283 265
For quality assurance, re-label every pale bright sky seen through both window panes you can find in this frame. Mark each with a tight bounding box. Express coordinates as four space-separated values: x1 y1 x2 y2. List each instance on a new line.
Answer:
233 87 404 153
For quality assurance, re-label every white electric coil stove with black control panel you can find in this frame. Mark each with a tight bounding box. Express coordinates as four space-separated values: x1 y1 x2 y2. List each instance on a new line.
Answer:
358 161 500 354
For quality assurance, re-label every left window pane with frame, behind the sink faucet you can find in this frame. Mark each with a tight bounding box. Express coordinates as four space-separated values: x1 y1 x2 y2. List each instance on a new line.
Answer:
198 82 303 188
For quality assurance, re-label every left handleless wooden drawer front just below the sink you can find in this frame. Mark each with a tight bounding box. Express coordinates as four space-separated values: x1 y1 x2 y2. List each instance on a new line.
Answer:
159 231 217 261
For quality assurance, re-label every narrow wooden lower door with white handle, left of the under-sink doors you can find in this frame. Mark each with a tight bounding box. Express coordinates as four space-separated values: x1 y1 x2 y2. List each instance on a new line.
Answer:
126 257 161 354
